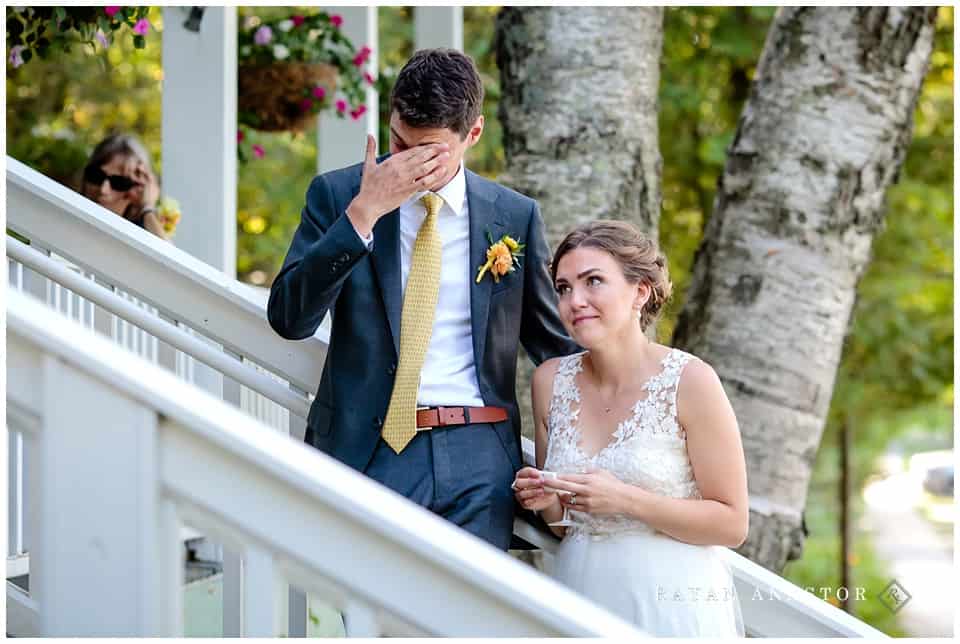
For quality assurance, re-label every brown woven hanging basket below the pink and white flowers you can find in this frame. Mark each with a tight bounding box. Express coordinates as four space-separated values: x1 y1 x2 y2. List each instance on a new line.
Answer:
237 62 337 132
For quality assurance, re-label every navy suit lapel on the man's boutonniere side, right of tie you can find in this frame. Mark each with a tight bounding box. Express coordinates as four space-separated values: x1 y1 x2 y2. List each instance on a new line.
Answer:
466 171 505 378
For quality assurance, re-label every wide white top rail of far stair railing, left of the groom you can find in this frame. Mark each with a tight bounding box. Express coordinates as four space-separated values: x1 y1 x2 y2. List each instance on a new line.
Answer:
6 156 329 392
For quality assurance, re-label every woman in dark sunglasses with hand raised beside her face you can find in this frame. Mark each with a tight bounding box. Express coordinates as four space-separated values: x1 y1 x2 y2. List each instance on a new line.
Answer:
80 134 167 239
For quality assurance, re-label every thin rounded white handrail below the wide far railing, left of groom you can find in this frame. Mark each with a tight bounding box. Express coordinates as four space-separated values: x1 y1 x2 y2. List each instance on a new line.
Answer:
7 238 310 418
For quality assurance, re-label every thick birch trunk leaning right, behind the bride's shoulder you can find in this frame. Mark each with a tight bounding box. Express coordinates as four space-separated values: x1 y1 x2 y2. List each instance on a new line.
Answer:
674 7 936 572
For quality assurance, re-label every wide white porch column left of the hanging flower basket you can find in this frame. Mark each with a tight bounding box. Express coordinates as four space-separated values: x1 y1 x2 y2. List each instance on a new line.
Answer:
163 7 237 277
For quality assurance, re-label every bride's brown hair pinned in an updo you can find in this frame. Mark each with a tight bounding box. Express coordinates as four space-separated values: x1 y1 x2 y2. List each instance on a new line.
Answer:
550 219 673 331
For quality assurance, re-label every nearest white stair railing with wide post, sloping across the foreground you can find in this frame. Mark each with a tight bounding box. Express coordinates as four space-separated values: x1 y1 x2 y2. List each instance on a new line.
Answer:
7 292 643 639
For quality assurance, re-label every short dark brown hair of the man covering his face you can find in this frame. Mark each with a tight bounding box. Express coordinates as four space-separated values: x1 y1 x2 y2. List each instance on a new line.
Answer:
390 49 483 141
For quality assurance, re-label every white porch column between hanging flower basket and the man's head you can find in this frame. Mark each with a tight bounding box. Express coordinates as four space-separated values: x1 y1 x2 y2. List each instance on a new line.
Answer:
317 6 379 173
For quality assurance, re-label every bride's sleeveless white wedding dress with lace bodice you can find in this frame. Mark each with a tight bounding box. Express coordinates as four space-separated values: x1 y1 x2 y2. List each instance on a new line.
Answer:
544 349 743 637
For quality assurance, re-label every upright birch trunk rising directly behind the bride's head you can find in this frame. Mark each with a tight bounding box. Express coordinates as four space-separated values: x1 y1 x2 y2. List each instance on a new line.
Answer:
496 7 663 452
